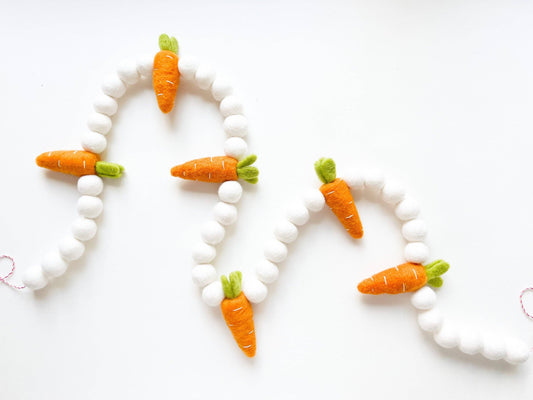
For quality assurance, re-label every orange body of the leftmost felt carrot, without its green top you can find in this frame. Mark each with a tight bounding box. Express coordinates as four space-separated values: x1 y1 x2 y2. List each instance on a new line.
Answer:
35 150 100 176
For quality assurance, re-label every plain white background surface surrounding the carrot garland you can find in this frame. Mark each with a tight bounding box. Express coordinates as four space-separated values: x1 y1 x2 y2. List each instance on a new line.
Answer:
0 0 533 400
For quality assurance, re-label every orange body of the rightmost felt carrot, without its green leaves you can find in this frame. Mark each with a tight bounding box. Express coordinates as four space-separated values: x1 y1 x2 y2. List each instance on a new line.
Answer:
357 263 427 294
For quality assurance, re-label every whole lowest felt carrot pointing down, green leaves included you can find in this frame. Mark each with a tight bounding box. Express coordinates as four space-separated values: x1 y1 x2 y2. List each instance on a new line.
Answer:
220 271 255 357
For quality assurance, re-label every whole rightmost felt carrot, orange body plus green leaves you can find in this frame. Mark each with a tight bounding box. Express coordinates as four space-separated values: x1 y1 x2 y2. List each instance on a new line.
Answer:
357 260 450 294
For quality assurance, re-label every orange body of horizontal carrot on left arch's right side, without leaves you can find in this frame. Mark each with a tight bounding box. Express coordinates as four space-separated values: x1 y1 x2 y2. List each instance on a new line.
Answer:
170 156 239 182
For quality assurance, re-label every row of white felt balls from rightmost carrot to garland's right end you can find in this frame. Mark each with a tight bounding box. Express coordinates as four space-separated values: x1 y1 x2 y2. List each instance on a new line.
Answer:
411 286 530 364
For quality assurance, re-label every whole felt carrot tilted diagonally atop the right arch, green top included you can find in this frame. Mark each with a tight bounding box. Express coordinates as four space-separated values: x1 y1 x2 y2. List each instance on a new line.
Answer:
315 158 363 239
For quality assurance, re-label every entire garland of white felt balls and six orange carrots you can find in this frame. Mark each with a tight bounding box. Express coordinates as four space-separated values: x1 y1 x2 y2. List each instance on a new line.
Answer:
0 34 530 364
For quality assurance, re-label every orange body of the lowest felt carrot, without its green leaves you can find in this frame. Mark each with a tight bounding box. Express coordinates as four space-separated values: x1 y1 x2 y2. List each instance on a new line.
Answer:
220 292 255 357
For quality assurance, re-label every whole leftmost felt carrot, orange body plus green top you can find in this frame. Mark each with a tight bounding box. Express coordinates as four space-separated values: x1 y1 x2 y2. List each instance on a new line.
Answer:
35 150 124 178
